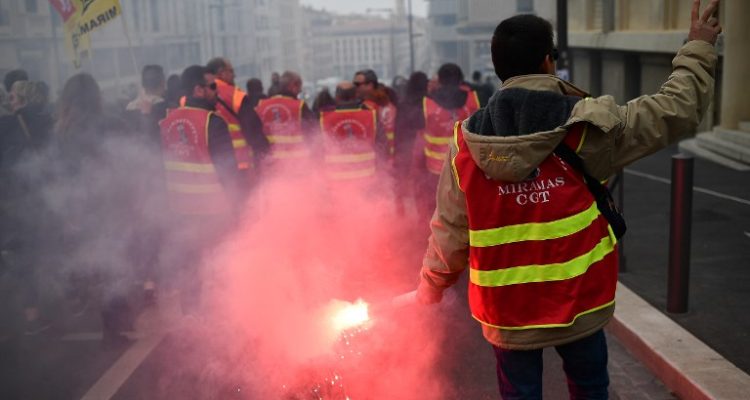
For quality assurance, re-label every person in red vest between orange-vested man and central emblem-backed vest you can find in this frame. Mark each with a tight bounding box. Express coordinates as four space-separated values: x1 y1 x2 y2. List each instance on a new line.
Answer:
255 71 318 163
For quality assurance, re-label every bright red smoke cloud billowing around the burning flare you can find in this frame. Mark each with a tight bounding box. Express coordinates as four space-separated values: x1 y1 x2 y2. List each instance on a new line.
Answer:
206 161 452 400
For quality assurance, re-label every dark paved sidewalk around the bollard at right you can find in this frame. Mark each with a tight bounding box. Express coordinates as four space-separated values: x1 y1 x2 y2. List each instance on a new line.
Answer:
620 147 750 373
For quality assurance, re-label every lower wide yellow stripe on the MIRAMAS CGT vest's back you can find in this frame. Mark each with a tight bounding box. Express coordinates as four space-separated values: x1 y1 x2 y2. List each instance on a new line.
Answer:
469 235 615 287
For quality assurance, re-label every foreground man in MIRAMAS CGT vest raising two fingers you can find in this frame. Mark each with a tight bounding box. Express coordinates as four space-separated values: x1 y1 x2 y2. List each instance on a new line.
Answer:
417 4 721 399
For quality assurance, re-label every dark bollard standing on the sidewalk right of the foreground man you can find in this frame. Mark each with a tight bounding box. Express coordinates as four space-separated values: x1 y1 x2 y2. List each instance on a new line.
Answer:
667 154 693 313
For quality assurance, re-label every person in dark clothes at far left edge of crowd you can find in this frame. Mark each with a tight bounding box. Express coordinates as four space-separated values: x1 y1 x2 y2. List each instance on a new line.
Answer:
0 80 53 336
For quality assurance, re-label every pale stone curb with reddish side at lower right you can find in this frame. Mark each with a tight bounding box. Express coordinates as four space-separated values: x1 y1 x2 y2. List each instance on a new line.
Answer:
607 282 750 400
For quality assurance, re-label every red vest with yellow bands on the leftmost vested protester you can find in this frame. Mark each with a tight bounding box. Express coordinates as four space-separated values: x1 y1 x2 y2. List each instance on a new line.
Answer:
159 107 229 215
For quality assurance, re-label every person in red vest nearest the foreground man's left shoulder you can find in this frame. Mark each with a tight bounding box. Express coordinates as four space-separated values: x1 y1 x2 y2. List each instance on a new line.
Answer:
414 63 479 220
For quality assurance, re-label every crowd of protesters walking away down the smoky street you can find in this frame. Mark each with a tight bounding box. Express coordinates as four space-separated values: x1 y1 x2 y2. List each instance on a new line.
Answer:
0 58 494 345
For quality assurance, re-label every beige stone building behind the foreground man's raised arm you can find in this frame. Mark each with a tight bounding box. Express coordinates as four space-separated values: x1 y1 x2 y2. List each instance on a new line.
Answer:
568 0 750 169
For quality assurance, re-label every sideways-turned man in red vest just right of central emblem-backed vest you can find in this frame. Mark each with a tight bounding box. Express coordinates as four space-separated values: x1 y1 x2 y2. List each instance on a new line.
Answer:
353 69 397 159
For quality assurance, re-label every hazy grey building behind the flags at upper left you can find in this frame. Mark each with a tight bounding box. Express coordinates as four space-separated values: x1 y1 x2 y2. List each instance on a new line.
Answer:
0 0 288 99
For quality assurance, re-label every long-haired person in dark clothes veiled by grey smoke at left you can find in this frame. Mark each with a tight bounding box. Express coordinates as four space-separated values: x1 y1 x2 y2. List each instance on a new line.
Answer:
46 73 135 345
